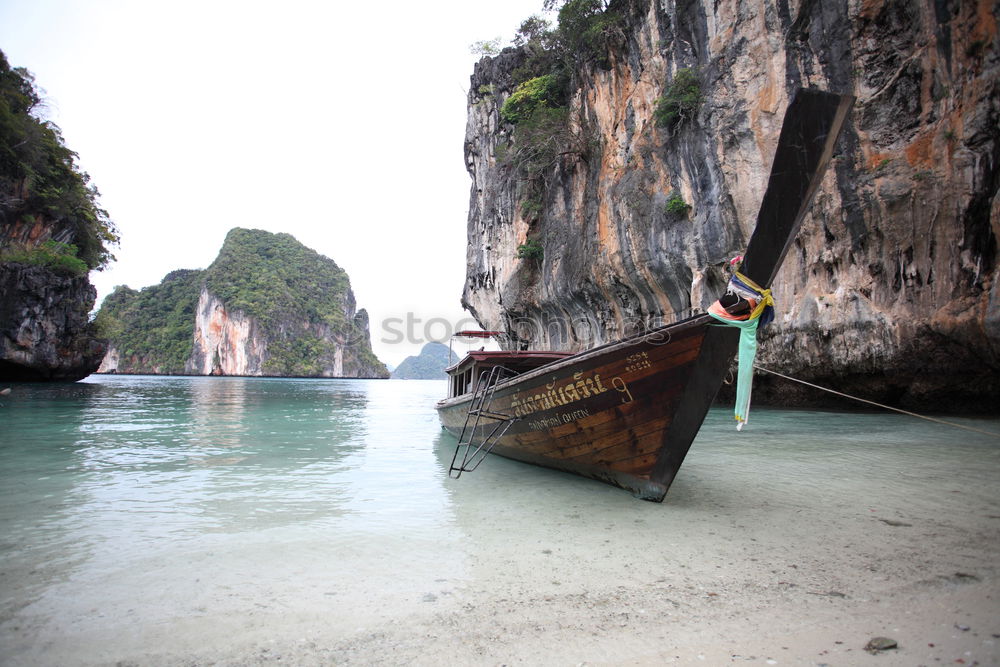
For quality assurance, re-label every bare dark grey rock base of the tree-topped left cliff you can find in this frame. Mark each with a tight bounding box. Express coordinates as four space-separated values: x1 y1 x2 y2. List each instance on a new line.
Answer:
0 263 105 382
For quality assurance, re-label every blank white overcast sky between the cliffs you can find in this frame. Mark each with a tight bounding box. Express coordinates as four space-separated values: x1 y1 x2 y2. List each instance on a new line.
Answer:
0 0 542 365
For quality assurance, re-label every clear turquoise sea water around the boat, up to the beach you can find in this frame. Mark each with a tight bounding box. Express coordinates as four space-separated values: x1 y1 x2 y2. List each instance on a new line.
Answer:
0 376 1000 664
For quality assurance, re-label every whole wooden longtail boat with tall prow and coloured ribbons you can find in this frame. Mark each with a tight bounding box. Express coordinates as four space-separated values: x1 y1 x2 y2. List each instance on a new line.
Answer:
437 89 854 502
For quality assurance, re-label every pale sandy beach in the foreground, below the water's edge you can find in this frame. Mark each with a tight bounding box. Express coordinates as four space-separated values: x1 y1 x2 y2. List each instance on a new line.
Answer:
13 491 1000 665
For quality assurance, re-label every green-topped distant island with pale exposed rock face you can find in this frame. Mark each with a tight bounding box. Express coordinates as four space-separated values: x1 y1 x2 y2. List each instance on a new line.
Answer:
95 228 389 378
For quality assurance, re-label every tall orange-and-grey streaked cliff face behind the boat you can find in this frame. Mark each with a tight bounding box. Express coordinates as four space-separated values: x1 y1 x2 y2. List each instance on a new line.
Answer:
463 0 1000 412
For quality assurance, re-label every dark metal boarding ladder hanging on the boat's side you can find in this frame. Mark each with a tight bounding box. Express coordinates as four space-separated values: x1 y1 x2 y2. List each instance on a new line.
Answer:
448 366 517 479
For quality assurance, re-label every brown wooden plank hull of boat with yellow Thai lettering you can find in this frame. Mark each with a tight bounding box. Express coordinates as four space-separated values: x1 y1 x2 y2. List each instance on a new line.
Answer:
438 315 736 501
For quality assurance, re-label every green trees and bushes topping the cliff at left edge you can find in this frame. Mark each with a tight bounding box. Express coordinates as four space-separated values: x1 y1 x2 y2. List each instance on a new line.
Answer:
0 51 118 274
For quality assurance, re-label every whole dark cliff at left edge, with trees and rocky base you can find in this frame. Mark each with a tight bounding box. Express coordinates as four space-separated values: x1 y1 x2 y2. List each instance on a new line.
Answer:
0 51 118 381
